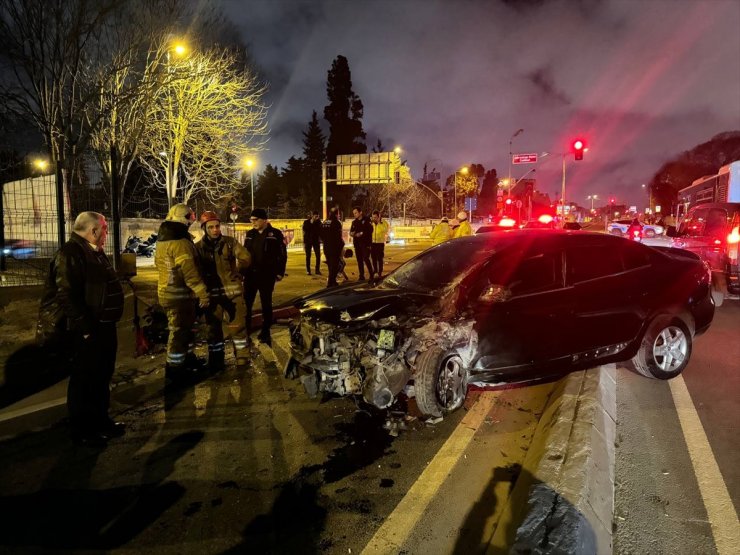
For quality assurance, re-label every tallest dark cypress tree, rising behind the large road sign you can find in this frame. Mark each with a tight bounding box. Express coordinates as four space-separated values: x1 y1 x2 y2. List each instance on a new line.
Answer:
324 55 367 214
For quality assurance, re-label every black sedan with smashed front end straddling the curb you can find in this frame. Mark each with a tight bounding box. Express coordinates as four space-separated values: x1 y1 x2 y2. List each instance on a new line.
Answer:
286 230 714 416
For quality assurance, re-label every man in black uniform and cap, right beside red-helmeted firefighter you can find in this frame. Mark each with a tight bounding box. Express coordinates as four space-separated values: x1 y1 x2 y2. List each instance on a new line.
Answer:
244 208 288 345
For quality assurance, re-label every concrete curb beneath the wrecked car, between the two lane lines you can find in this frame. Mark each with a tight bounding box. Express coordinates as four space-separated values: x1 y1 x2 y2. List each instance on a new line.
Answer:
489 364 616 555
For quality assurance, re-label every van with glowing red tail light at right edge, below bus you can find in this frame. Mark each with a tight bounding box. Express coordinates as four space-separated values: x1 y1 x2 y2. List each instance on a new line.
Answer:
671 202 740 295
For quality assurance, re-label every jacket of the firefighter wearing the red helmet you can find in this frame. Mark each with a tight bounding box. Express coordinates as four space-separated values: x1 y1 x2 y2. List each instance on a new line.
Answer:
195 235 252 299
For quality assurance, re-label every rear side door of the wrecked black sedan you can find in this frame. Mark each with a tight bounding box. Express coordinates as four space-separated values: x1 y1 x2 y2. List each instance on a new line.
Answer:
565 236 651 357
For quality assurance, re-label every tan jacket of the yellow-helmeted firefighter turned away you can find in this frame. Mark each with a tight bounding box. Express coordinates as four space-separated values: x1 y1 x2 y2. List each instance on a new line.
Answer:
154 221 208 308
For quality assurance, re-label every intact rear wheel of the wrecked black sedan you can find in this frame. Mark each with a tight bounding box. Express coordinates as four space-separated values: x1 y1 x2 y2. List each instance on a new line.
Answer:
632 316 692 380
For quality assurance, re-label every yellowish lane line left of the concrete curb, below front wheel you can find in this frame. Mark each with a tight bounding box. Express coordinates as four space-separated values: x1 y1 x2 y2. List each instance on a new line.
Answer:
362 393 498 555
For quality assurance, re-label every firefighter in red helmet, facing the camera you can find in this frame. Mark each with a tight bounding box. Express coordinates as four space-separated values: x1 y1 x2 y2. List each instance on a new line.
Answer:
195 210 252 372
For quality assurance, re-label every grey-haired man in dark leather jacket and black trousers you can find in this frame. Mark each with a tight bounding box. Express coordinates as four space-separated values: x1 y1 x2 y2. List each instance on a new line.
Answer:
41 212 125 447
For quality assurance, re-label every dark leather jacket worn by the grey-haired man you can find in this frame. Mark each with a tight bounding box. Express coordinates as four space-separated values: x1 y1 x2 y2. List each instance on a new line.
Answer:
38 233 124 339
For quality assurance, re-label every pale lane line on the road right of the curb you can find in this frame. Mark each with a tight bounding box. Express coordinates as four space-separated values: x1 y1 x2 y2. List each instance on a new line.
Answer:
668 375 740 555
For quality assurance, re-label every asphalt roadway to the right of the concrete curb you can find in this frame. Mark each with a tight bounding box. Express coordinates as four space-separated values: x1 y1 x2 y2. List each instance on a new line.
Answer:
614 301 740 554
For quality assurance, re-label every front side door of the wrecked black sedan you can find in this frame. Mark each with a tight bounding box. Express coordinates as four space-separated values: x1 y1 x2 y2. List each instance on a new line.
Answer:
471 240 572 380
